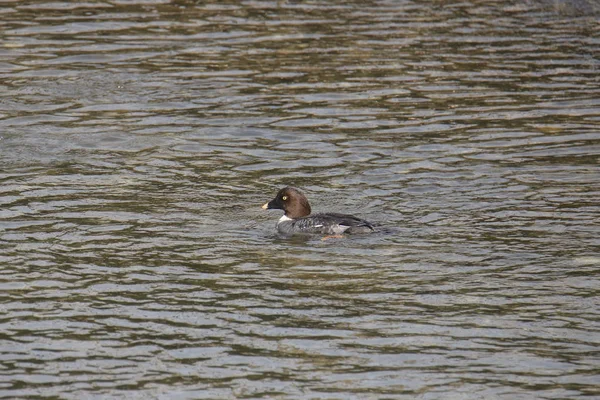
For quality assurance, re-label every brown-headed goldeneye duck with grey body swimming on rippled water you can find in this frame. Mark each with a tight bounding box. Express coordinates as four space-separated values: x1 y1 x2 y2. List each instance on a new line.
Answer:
262 186 375 235
